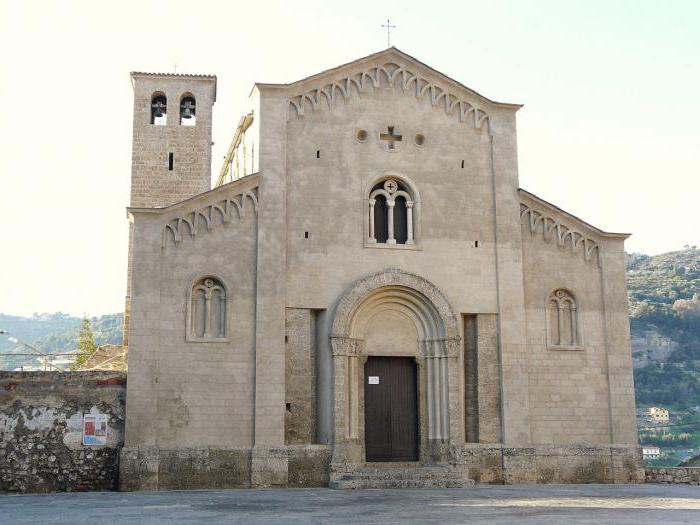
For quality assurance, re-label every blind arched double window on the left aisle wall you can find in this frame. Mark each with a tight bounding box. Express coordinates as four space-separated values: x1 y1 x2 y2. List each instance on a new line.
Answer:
187 277 226 341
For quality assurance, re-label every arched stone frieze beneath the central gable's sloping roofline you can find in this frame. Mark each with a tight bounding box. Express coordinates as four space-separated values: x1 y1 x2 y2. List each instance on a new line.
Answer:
289 62 489 129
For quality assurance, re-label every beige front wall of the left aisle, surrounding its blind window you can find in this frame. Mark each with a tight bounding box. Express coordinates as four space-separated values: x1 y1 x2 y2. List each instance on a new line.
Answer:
124 173 258 450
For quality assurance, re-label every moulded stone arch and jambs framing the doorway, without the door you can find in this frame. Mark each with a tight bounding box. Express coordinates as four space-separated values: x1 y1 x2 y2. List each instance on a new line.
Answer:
331 269 462 466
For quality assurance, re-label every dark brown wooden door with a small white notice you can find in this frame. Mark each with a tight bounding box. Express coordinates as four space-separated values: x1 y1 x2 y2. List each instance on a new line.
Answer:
365 357 418 461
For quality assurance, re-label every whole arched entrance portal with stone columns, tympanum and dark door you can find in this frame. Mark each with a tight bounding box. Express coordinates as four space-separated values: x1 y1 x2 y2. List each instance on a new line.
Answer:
331 269 462 470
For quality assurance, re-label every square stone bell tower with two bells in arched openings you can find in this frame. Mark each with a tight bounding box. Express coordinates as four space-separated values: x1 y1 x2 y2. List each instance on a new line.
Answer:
130 72 216 208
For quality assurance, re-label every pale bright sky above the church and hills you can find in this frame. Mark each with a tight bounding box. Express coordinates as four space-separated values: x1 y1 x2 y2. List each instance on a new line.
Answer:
0 0 700 315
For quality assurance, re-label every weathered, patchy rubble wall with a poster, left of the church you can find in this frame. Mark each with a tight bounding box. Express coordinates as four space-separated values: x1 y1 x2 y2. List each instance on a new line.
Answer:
0 372 126 492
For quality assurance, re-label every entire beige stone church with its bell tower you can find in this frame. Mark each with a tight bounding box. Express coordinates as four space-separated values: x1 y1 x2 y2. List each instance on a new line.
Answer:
120 47 643 490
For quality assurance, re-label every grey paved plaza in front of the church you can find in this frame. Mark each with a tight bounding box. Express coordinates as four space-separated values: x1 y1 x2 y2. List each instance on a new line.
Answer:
0 485 700 525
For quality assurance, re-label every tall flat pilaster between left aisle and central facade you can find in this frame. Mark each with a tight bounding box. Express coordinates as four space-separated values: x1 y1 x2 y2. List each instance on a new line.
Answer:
252 87 287 486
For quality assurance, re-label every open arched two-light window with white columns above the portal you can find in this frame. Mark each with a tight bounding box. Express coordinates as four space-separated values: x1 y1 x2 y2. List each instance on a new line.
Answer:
368 178 415 244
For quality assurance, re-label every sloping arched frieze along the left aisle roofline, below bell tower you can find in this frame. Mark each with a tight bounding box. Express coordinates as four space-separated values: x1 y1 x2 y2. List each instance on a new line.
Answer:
163 190 258 246
